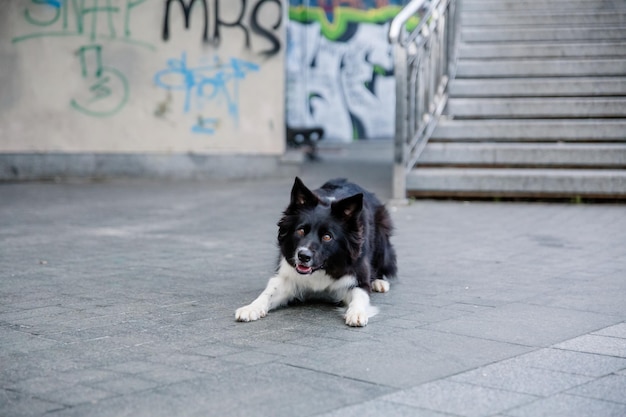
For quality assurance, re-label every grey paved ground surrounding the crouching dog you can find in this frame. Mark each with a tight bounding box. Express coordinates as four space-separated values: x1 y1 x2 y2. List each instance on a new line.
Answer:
0 141 626 417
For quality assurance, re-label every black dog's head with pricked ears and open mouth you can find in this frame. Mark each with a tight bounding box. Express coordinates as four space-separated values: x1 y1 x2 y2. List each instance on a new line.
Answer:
278 177 363 277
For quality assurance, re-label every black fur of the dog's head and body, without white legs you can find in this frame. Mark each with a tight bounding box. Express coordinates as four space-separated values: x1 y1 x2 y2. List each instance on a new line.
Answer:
278 178 397 292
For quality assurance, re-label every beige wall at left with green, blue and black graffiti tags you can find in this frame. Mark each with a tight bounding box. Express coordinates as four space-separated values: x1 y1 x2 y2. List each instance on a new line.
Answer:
0 0 286 154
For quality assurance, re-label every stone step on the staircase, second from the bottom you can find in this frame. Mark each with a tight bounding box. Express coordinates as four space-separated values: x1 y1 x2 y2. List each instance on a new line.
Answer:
417 142 626 168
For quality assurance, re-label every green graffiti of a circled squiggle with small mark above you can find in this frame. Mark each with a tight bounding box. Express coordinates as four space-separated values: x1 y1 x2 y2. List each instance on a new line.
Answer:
70 45 128 117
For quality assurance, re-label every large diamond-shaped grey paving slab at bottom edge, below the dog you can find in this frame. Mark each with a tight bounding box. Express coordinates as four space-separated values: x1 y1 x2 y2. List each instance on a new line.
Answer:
120 364 390 417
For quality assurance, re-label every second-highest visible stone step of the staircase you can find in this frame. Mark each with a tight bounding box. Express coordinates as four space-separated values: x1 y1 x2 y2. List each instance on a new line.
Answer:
462 9 626 28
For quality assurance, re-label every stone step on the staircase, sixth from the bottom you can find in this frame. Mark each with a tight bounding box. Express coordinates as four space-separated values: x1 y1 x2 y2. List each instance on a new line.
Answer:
456 58 626 78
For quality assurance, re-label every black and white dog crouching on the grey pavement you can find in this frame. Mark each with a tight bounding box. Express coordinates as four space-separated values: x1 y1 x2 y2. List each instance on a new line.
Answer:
235 178 397 326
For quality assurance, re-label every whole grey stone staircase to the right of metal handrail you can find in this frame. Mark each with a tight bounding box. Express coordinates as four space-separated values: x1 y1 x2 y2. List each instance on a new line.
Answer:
406 0 626 199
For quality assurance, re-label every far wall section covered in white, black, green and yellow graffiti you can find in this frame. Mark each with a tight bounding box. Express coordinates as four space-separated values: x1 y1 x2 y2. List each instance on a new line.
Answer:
287 0 407 142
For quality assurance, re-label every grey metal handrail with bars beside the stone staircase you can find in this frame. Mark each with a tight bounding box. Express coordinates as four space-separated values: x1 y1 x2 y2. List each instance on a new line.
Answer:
388 0 456 199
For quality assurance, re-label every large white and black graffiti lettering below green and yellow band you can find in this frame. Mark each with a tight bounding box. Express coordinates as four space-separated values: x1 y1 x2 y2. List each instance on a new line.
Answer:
287 17 395 141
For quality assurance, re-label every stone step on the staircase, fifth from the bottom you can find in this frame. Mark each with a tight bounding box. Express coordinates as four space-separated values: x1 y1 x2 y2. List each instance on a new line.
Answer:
448 77 626 98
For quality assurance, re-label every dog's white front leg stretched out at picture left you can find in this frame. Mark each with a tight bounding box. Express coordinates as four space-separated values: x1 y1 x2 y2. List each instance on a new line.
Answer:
235 275 295 321
